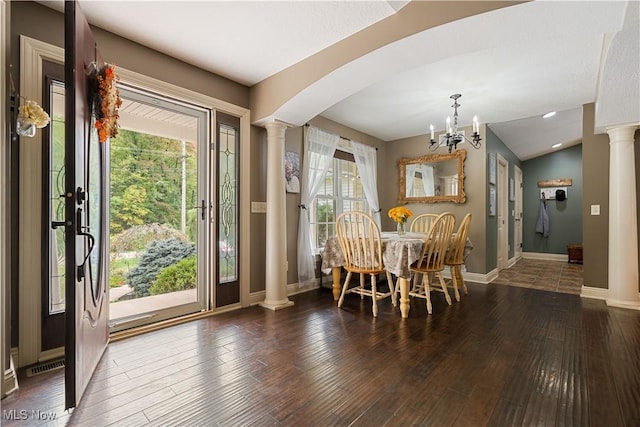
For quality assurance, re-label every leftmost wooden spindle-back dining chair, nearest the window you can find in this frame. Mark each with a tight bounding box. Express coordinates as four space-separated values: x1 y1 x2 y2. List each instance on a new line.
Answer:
336 211 395 317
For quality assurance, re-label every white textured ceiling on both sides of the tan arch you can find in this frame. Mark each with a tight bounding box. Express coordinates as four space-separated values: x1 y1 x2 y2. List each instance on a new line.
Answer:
42 0 640 160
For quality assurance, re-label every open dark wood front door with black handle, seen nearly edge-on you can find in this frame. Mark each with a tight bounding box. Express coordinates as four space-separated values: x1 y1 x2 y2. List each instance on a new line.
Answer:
65 1 109 408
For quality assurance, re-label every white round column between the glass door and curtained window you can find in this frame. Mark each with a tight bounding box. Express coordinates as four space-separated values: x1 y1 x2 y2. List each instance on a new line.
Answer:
260 122 293 310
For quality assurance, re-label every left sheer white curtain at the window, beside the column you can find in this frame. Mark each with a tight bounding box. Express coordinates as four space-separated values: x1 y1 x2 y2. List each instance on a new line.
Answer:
298 126 340 285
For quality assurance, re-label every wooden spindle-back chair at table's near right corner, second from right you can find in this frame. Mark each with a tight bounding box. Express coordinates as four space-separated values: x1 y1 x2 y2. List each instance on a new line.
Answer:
409 212 456 314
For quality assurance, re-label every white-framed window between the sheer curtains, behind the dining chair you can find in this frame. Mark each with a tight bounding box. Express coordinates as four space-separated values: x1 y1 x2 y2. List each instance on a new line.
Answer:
309 150 371 253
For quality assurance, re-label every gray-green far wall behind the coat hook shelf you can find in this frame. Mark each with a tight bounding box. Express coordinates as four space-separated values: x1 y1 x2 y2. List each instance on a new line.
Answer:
522 144 582 254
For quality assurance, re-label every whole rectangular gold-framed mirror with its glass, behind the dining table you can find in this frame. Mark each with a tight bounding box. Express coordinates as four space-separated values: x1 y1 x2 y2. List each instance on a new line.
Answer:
398 149 467 203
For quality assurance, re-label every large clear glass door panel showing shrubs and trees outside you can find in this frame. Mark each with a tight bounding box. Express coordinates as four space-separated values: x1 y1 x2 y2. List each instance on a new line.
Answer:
109 88 210 331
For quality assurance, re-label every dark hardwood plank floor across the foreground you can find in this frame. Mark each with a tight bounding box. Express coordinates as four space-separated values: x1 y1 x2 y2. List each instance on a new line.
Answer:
2 283 640 427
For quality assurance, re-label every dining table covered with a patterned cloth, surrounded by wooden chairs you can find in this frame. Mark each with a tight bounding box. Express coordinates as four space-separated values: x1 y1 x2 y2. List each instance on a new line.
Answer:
321 231 473 318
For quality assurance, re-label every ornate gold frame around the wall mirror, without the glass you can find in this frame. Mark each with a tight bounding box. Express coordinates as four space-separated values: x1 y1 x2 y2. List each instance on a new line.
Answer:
398 149 467 204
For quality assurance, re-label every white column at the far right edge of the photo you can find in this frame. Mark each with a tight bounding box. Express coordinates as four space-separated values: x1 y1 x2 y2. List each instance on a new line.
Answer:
607 126 640 310
